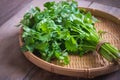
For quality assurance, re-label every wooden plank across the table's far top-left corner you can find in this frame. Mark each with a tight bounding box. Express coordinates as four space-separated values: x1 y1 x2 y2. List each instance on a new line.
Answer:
0 0 32 25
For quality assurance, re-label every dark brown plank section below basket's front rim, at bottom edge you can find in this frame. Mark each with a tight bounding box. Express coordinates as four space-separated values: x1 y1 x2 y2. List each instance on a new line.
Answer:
24 67 79 80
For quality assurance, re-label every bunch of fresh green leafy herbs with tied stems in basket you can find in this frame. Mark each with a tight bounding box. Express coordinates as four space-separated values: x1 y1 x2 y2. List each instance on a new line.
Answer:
20 0 120 64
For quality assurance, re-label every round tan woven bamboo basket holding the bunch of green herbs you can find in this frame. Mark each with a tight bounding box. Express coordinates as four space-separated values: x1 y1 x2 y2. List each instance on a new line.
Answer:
19 8 120 78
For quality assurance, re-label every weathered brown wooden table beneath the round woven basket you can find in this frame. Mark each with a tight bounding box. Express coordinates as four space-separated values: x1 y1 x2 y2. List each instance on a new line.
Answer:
0 0 120 80
